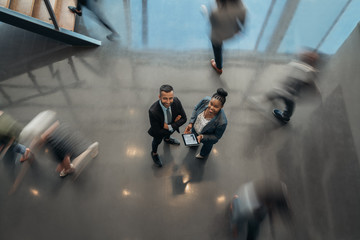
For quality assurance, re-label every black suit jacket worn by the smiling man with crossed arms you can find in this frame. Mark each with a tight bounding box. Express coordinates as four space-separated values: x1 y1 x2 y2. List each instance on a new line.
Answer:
148 97 187 138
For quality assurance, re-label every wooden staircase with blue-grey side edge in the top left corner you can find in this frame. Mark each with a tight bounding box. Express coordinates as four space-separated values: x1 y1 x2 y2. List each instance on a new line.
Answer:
0 0 101 46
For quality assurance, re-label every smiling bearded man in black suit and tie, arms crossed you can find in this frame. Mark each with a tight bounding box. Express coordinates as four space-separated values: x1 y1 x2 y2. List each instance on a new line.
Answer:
148 85 187 167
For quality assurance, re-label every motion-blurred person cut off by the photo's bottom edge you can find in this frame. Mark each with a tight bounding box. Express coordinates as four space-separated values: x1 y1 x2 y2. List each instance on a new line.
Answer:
230 179 292 240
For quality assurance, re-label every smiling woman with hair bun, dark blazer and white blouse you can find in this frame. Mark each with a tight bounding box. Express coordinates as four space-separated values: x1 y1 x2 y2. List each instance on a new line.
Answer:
184 88 228 159
